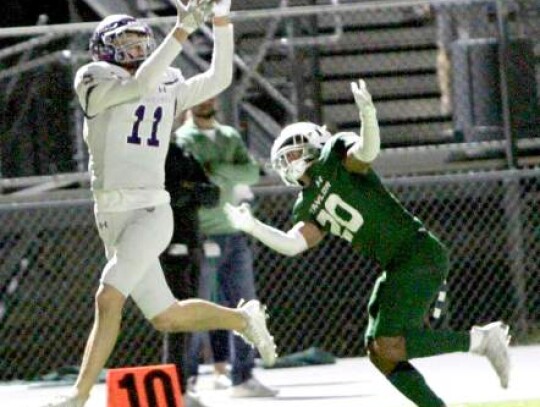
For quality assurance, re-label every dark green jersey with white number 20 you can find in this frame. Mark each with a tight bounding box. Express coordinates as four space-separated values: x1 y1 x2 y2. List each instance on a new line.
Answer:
293 133 435 267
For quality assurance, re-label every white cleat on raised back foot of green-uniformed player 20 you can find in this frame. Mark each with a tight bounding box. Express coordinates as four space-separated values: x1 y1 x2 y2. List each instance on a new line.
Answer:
471 321 511 389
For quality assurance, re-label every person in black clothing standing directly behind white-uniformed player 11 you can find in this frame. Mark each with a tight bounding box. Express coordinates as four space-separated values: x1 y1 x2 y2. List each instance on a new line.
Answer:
160 143 219 406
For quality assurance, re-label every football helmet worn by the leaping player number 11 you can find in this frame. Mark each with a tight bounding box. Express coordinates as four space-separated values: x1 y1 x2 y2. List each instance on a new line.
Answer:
90 14 156 66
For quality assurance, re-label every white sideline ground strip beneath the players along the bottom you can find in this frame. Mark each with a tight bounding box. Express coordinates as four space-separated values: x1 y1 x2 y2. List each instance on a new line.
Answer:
0 345 540 407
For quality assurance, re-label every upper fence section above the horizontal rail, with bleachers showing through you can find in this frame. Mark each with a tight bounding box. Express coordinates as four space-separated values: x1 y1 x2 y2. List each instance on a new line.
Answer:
0 0 540 177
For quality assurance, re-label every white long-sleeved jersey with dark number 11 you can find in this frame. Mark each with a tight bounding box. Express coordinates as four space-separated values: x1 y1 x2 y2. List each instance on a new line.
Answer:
75 26 233 212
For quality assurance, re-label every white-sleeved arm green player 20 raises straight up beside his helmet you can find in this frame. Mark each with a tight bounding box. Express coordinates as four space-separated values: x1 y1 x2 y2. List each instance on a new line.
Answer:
346 79 381 170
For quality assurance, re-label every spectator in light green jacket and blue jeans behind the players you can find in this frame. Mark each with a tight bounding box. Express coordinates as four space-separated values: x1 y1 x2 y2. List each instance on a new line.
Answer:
176 98 277 397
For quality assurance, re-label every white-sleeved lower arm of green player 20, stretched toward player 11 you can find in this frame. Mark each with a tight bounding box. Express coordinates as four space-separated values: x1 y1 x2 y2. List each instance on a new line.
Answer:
224 204 323 256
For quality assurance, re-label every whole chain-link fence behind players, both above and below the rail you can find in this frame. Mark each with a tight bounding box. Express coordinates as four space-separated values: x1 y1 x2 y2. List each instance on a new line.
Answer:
0 0 540 386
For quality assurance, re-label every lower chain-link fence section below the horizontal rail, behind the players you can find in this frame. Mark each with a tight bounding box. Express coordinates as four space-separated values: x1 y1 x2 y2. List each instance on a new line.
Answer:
0 168 540 380
